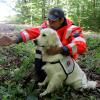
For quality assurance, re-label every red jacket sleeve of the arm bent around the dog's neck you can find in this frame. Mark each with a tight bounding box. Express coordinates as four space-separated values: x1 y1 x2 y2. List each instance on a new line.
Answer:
66 25 87 57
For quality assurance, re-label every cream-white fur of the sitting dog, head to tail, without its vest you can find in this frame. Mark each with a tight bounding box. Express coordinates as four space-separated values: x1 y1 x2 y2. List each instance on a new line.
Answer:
34 28 97 96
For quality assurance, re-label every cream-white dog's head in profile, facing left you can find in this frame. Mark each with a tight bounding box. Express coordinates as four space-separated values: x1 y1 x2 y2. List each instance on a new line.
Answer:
35 28 62 48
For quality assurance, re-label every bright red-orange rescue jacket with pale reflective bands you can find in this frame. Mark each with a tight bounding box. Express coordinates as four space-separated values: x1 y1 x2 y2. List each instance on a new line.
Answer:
20 19 86 59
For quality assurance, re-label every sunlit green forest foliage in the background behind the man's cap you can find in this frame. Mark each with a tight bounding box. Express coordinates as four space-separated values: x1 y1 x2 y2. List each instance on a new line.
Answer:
13 0 100 31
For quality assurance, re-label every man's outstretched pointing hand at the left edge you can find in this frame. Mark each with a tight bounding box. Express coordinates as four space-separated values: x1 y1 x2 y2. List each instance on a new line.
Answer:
0 35 15 46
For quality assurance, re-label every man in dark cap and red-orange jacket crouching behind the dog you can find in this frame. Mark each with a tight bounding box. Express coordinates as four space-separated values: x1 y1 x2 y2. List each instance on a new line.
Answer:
0 8 86 81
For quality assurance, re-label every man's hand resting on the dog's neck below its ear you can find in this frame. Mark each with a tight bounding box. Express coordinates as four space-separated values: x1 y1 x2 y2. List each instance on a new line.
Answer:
46 46 62 55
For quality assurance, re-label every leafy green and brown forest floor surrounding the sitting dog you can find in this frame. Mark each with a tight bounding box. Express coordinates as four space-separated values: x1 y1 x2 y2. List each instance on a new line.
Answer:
0 24 100 100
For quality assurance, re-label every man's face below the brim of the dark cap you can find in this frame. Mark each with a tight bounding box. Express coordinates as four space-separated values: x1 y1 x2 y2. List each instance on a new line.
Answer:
48 18 64 30
